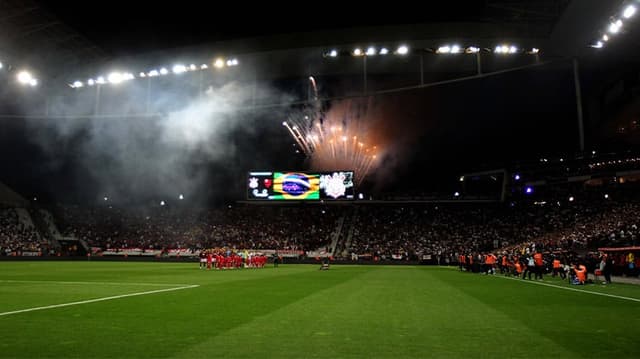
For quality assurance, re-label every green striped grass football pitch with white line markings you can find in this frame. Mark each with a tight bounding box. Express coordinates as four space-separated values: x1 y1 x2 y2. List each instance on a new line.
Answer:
0 262 640 359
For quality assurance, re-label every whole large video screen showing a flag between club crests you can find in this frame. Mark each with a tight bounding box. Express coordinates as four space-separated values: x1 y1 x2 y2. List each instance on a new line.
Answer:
247 171 354 201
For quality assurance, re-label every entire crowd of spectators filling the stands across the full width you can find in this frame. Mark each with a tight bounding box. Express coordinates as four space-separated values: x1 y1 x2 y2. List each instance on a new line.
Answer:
0 193 640 264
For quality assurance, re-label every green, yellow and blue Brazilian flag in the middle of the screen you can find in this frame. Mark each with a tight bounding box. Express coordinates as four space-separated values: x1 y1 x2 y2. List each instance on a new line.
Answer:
270 172 320 200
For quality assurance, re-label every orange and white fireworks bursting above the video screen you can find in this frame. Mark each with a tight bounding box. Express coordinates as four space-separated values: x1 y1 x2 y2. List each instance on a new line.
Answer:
282 89 379 184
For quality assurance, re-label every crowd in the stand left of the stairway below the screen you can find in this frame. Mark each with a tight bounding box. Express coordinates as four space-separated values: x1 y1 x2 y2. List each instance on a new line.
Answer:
56 206 339 251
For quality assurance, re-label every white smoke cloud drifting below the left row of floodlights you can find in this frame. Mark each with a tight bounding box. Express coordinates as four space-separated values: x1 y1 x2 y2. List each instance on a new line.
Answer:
24 76 290 202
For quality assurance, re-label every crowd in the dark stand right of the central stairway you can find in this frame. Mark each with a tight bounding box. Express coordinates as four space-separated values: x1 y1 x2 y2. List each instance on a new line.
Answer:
348 201 640 263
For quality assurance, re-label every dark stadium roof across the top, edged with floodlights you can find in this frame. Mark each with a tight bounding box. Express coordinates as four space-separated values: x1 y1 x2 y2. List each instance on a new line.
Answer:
0 0 637 88
